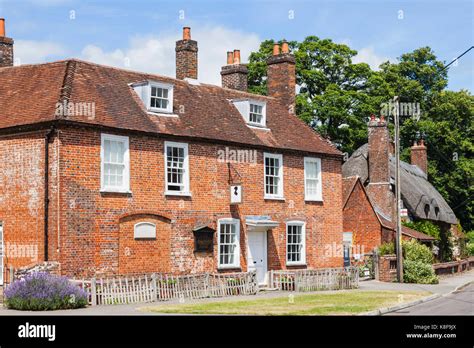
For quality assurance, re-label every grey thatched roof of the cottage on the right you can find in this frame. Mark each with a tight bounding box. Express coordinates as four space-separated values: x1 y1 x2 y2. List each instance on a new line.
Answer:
342 144 457 224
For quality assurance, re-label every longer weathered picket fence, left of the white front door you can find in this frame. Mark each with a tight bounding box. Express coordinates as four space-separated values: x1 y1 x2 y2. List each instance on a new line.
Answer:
72 272 258 305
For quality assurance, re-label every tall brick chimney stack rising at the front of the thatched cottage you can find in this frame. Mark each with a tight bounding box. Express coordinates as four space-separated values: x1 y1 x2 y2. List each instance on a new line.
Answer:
367 115 394 219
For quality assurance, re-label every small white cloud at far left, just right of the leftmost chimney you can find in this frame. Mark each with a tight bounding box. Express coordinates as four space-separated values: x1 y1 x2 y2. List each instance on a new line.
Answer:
15 40 66 65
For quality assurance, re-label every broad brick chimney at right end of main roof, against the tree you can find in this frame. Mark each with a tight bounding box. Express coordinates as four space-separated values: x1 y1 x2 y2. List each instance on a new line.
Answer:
267 41 296 114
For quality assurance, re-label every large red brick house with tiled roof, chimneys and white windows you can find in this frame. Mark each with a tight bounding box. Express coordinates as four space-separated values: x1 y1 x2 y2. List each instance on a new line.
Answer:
0 23 343 282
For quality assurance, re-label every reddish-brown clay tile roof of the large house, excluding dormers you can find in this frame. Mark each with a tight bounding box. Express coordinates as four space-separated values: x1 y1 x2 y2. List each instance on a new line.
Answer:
0 60 342 157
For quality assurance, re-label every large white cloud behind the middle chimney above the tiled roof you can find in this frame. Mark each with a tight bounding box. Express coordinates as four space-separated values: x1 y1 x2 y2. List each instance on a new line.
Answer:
82 26 261 85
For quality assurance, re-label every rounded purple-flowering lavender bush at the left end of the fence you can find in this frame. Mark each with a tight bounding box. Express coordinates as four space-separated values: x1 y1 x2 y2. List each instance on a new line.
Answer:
5 272 87 311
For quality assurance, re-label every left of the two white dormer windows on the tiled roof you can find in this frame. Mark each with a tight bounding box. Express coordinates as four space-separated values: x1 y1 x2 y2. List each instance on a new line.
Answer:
132 81 173 114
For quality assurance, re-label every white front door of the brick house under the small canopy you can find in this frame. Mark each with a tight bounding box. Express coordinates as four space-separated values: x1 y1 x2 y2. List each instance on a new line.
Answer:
247 231 267 284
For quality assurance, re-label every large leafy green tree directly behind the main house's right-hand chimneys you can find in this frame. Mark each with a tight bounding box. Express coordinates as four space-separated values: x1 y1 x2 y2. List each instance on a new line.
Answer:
248 36 381 151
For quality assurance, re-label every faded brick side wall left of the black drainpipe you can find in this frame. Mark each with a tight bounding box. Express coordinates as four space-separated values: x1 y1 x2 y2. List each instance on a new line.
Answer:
0 132 50 268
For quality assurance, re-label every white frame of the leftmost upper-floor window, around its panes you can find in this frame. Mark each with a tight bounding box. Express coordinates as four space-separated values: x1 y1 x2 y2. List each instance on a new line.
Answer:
100 133 130 193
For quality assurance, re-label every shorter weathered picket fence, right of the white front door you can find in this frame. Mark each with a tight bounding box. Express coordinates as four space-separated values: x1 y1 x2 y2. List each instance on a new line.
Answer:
270 267 359 291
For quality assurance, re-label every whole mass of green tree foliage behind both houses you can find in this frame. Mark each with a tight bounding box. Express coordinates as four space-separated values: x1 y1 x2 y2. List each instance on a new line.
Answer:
248 36 474 231
